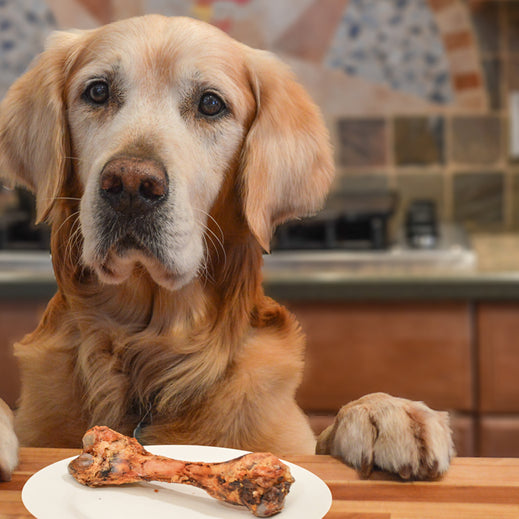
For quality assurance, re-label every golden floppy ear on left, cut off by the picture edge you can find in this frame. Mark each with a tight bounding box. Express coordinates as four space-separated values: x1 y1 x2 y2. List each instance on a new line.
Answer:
0 32 78 222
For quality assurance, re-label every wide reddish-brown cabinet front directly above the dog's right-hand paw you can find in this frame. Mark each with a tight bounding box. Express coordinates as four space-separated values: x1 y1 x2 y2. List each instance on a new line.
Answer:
288 302 473 412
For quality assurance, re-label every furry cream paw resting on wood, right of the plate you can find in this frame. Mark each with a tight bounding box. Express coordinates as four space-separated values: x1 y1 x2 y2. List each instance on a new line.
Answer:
316 393 454 479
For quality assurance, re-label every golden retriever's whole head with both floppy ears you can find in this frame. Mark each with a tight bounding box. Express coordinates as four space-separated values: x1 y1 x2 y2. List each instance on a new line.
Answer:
0 16 333 289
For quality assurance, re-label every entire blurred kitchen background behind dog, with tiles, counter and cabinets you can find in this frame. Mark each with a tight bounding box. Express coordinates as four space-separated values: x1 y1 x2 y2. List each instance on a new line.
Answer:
0 0 519 456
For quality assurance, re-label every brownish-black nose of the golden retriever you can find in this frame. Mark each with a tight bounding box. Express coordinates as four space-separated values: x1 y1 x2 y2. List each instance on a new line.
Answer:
100 157 168 215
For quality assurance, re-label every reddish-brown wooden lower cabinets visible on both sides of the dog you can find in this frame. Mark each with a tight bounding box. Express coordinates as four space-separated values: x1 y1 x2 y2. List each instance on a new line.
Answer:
0 301 519 456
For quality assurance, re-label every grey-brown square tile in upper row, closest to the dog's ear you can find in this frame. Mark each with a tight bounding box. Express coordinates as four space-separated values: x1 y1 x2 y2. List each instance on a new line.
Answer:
337 119 387 167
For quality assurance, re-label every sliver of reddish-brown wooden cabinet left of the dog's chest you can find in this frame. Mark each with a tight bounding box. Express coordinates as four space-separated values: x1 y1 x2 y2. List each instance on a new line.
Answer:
0 301 46 407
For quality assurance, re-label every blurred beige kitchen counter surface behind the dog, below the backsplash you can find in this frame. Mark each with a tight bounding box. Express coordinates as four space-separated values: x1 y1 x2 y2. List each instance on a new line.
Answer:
0 234 519 301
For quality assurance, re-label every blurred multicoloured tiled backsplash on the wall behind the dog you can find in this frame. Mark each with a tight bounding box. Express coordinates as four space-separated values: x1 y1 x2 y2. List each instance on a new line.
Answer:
0 0 519 237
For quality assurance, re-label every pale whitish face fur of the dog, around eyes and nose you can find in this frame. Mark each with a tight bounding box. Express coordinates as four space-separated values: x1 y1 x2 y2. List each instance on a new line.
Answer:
67 18 253 288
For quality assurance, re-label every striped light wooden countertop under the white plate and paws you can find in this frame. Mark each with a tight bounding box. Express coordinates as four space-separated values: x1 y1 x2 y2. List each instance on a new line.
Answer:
0 448 519 519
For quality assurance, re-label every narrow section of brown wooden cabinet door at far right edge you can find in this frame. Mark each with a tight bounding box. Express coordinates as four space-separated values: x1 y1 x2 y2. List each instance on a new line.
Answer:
477 303 519 413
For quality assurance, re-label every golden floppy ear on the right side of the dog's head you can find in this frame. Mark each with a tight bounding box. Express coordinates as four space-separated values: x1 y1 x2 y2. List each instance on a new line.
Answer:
241 50 334 251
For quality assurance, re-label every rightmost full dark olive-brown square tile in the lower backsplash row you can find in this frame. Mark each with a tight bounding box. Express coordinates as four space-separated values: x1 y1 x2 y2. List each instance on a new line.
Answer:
453 172 504 229
